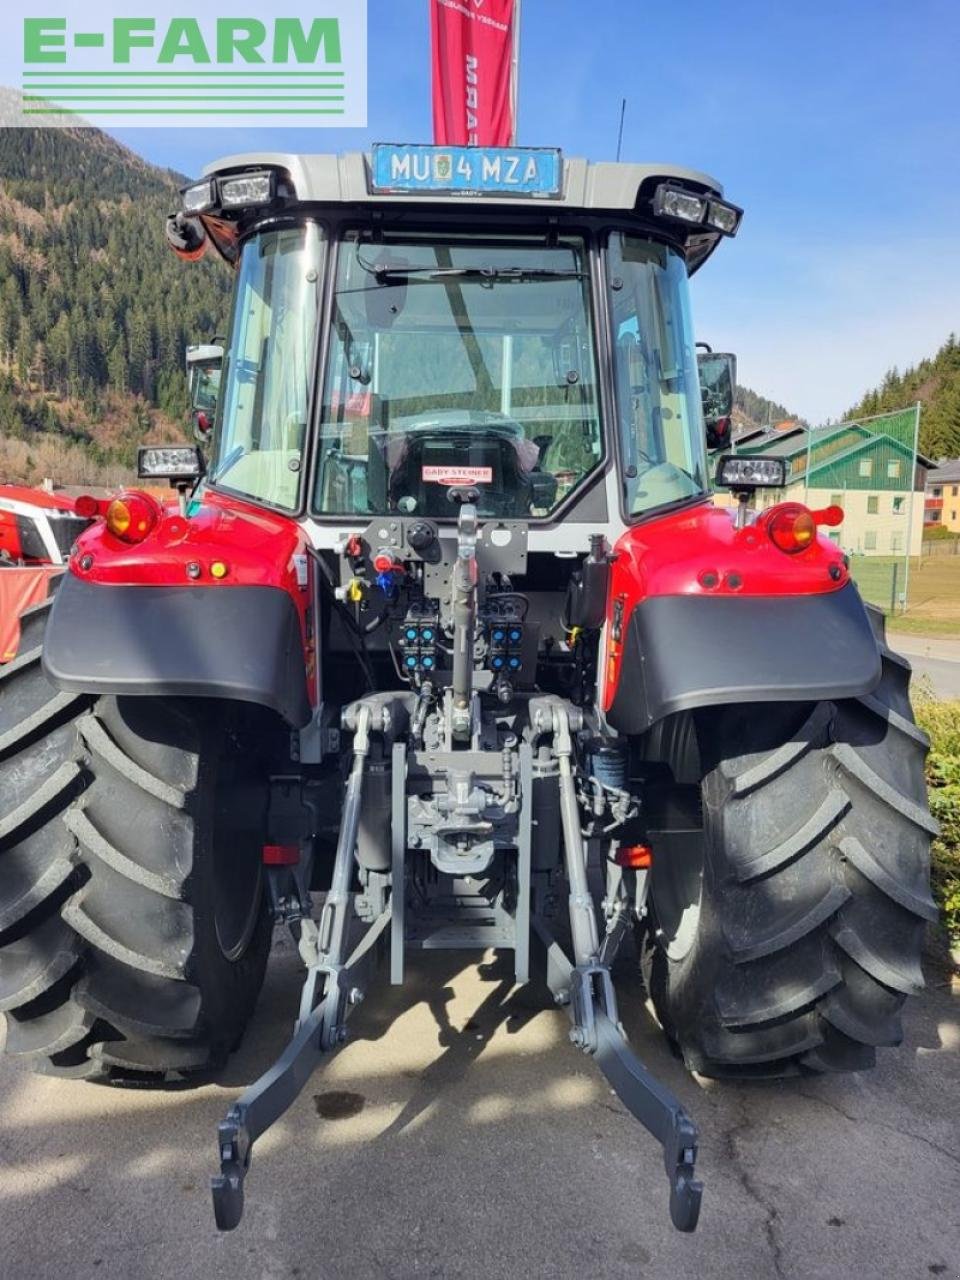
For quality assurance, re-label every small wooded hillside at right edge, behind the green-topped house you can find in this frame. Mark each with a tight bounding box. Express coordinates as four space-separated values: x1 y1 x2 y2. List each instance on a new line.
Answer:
844 333 960 460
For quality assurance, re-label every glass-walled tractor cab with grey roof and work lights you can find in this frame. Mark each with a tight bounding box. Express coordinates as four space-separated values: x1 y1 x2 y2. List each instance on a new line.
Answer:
173 147 740 553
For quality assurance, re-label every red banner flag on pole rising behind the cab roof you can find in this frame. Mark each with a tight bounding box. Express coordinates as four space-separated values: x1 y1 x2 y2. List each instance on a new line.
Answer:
430 0 520 147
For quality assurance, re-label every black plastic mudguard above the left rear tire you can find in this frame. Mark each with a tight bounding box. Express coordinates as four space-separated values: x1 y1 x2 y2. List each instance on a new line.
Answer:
44 573 310 728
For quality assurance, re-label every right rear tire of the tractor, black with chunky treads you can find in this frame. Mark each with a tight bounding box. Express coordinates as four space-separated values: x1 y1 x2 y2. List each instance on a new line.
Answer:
641 617 937 1076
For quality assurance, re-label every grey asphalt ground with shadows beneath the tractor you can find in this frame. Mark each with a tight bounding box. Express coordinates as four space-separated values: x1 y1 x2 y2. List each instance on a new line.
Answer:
0 934 960 1280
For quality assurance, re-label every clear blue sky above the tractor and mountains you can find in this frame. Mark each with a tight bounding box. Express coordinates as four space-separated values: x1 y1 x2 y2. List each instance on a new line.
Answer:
106 0 960 421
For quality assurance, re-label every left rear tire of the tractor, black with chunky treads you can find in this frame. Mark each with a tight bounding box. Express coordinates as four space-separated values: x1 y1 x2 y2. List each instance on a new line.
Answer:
0 603 271 1082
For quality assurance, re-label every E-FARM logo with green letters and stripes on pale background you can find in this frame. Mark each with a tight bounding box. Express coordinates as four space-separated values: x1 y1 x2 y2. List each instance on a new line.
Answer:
0 0 366 128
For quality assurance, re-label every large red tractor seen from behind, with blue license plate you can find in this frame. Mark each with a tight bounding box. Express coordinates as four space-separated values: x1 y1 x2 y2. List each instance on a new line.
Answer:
0 146 936 1230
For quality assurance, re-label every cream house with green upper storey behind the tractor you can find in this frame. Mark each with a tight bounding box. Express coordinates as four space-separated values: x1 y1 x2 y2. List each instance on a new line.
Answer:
736 410 936 556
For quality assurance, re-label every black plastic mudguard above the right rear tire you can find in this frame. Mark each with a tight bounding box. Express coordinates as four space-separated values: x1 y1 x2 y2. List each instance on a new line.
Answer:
607 582 881 733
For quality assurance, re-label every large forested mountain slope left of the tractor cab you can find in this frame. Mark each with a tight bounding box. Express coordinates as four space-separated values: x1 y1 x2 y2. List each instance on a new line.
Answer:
0 119 230 483
